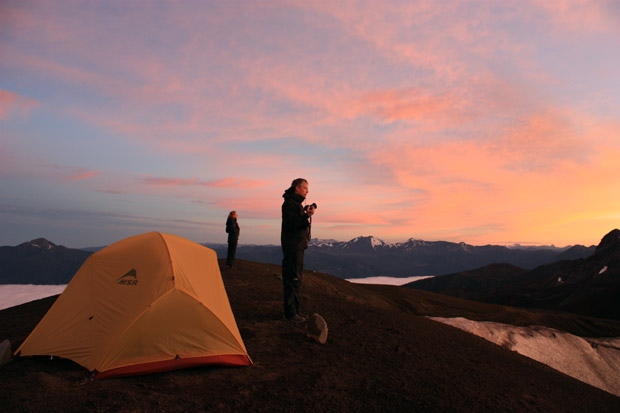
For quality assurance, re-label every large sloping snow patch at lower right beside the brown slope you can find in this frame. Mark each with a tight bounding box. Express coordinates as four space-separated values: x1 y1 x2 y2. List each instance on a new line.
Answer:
429 317 620 396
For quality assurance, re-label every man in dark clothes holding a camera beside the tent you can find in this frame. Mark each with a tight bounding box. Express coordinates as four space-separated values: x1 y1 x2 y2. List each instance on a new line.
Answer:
280 178 316 323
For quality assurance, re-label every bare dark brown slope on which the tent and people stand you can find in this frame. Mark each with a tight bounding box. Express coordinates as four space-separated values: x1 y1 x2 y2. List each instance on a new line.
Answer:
0 261 620 411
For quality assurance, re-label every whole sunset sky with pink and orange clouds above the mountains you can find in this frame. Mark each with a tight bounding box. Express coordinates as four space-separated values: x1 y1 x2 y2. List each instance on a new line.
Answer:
0 0 620 248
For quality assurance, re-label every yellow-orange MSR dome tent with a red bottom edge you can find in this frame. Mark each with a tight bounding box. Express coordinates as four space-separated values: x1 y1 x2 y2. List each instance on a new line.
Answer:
15 232 252 378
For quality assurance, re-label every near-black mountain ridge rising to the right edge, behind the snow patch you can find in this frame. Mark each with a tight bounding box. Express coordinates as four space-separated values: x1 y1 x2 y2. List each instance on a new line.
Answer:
407 229 620 320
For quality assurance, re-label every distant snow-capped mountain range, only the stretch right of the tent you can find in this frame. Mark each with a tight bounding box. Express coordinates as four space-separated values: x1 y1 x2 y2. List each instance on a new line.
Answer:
206 236 595 278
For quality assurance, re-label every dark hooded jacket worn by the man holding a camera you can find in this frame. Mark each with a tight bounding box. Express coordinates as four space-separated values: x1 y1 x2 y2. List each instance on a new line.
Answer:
280 188 310 251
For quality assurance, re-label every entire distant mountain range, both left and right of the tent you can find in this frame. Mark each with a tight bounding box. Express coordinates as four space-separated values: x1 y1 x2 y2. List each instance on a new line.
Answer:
0 236 595 284
